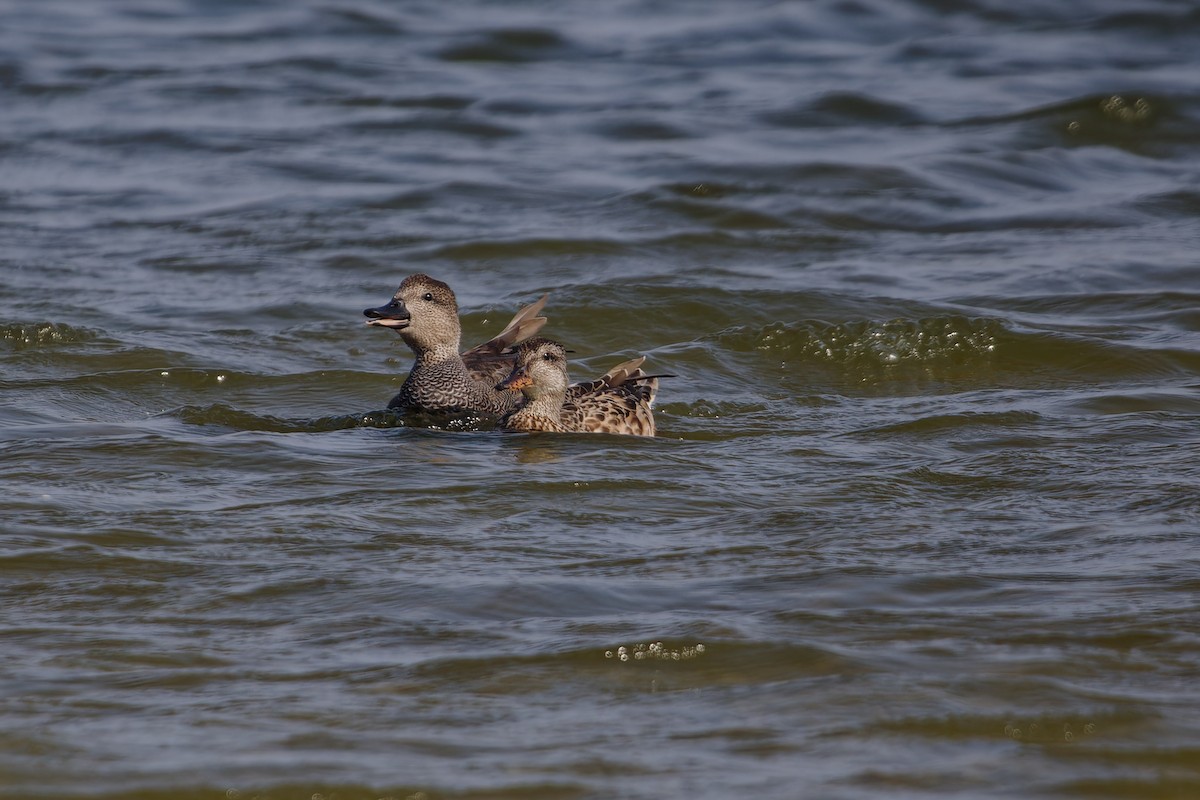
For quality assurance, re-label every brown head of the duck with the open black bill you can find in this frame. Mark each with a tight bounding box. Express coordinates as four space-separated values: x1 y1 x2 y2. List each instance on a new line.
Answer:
362 272 462 359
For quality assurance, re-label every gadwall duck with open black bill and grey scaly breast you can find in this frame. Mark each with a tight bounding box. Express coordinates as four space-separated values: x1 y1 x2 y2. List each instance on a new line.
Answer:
362 273 546 416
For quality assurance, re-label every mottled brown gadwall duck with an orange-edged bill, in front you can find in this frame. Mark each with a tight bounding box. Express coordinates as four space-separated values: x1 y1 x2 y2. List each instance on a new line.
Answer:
496 337 668 437
